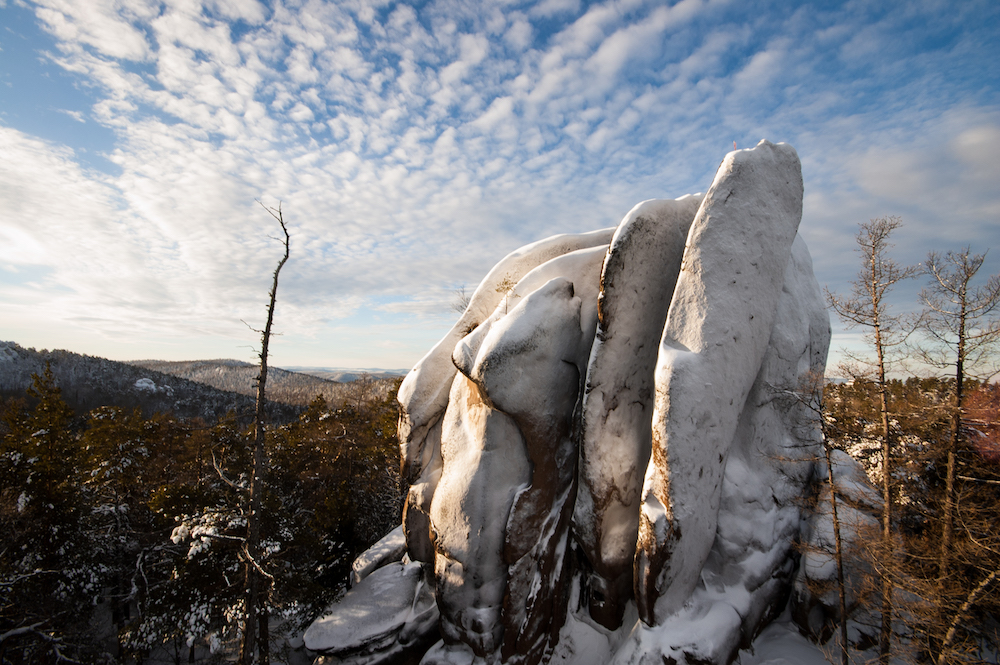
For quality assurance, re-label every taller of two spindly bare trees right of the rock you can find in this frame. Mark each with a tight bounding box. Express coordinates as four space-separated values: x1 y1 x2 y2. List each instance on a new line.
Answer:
826 217 918 665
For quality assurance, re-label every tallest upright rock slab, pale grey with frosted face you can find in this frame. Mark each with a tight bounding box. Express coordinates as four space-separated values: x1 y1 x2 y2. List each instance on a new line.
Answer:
635 141 802 625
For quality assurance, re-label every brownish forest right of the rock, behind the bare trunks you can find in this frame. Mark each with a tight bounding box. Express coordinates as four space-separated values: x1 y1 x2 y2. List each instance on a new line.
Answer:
823 377 1000 663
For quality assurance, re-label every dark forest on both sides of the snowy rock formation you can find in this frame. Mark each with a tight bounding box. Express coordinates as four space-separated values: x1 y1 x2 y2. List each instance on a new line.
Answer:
0 371 1000 663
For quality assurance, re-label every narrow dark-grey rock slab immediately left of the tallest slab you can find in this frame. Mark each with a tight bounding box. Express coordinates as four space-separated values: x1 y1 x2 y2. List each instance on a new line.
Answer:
573 195 702 629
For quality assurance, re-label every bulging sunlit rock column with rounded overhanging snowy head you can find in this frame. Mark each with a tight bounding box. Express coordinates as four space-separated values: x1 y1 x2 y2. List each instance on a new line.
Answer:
431 247 605 662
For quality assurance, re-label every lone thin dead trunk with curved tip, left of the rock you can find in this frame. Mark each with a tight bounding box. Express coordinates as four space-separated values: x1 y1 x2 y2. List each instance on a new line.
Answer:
239 201 290 665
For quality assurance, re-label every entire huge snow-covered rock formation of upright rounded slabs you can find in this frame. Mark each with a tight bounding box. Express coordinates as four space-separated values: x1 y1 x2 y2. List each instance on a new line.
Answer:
305 141 868 665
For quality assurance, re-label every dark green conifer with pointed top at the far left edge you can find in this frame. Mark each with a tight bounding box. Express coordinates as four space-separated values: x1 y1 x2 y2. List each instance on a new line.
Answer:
0 366 94 662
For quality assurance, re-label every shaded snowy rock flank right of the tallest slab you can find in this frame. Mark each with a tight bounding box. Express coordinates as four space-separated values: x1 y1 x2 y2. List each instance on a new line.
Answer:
614 230 830 663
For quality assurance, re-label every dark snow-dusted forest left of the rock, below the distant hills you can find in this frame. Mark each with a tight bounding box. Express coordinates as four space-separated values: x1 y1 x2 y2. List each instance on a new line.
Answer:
0 366 404 663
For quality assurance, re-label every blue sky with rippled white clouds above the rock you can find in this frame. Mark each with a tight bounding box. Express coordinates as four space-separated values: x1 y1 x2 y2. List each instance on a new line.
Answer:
0 0 1000 368
